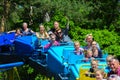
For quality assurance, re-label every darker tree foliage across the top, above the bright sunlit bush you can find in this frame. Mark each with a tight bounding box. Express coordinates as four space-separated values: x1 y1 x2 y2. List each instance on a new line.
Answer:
0 0 120 31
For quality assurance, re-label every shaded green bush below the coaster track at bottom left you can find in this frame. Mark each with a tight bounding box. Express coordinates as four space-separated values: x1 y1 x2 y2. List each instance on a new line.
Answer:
17 64 54 80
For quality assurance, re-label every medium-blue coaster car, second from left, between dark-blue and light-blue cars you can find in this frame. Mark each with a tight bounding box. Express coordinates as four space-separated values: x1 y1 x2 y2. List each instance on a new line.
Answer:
14 36 37 56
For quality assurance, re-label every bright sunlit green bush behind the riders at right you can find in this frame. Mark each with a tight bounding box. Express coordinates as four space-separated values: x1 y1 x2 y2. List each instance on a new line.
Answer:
69 26 120 55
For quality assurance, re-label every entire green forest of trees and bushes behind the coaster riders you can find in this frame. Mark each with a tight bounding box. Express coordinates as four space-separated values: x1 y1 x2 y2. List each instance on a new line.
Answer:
0 0 120 80
